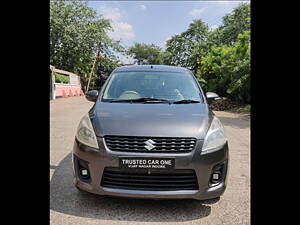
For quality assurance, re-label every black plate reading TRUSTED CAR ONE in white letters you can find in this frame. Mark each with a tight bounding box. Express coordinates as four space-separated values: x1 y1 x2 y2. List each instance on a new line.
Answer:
119 157 175 170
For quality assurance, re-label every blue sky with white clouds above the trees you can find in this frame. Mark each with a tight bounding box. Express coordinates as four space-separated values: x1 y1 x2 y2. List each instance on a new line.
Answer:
88 0 249 63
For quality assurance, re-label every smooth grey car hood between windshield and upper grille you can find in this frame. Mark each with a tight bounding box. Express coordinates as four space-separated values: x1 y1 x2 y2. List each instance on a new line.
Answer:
91 102 212 139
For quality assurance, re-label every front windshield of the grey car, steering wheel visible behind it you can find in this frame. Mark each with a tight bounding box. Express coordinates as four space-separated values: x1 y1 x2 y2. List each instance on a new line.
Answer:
102 71 201 102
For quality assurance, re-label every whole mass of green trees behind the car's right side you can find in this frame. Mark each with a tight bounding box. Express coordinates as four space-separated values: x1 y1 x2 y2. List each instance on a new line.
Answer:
161 4 250 103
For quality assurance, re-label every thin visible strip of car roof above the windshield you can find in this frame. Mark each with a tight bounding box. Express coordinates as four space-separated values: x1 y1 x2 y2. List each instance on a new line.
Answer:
114 65 190 73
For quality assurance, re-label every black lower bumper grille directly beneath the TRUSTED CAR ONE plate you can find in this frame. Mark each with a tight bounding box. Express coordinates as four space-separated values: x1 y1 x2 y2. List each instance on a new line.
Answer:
101 167 198 191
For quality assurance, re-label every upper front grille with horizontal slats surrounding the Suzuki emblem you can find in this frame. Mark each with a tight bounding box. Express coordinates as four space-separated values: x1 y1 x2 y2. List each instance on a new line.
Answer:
104 136 196 153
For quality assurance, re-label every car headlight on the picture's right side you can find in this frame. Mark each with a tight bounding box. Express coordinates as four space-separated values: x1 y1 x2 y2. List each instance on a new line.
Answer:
201 116 227 153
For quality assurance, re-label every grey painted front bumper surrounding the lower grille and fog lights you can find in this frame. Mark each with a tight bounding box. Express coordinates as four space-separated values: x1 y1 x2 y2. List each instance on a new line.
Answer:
72 137 229 200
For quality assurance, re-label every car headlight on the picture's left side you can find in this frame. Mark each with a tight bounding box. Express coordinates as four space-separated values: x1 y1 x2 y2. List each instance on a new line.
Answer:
76 113 99 149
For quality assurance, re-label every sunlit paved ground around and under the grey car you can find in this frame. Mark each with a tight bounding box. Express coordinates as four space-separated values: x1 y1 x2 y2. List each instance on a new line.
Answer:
50 97 250 225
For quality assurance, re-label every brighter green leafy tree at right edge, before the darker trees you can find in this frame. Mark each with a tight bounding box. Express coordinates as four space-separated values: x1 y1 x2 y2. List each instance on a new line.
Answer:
196 31 250 102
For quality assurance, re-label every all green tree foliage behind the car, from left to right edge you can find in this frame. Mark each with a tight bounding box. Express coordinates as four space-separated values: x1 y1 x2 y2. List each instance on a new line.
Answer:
50 0 250 103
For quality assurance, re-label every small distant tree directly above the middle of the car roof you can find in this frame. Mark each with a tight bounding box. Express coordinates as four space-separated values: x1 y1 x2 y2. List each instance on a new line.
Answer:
128 43 162 65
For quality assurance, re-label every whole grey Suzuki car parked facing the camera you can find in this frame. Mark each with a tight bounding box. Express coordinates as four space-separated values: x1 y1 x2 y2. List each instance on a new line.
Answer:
72 65 229 200
